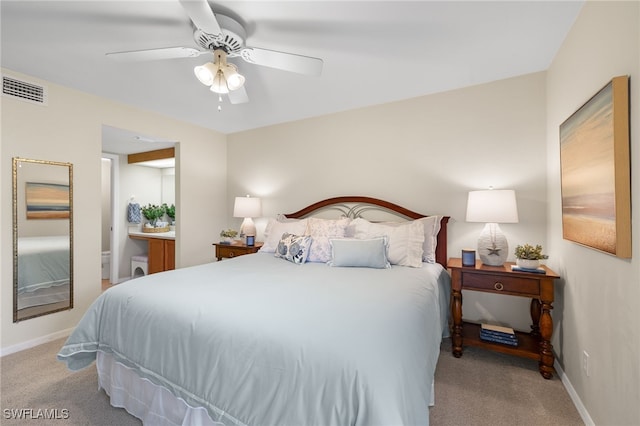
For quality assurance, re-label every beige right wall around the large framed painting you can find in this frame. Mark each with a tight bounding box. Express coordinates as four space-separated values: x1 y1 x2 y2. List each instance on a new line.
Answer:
547 2 640 425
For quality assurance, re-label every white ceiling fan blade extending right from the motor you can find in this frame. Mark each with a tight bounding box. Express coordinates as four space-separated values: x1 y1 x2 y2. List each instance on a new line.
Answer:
240 47 323 76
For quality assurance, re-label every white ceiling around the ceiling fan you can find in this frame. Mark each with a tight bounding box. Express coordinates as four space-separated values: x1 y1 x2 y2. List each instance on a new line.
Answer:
0 0 583 148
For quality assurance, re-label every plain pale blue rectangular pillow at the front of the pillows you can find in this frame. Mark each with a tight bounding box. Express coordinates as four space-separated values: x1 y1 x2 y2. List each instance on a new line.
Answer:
328 237 391 269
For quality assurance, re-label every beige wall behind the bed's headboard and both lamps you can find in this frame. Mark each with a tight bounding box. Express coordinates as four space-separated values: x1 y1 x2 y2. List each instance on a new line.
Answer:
228 73 555 330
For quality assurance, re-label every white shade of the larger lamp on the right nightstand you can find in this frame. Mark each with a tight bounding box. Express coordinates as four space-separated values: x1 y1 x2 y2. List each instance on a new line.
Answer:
467 189 518 223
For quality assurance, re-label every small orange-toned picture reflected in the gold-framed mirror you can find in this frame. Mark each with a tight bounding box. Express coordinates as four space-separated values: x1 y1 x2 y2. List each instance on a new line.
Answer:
25 182 69 219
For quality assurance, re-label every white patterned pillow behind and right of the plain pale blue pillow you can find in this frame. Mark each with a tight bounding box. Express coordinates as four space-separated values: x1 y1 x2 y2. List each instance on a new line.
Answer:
352 218 425 268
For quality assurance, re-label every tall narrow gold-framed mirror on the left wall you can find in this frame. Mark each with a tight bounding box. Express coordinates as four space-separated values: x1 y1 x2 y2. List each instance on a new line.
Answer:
13 157 73 322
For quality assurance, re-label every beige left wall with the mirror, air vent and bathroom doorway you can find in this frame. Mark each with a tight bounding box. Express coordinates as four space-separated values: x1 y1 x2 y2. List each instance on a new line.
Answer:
0 69 227 351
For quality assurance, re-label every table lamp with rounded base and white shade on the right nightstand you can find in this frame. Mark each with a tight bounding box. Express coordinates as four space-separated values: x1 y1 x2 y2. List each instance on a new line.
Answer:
467 189 518 266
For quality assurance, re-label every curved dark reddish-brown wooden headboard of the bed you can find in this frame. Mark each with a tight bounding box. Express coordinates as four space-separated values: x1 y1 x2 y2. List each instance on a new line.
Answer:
284 196 449 268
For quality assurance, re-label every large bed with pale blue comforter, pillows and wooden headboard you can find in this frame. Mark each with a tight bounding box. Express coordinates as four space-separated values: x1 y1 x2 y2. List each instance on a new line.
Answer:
58 197 450 425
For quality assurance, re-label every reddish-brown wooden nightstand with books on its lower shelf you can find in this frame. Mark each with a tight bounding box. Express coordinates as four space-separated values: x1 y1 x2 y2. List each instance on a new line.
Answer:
447 258 560 379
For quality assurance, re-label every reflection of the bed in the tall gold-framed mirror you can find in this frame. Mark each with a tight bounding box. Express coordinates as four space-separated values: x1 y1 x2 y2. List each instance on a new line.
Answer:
18 235 71 309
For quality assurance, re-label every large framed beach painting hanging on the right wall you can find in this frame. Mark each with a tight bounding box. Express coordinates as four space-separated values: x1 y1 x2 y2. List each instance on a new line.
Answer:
560 76 631 258
